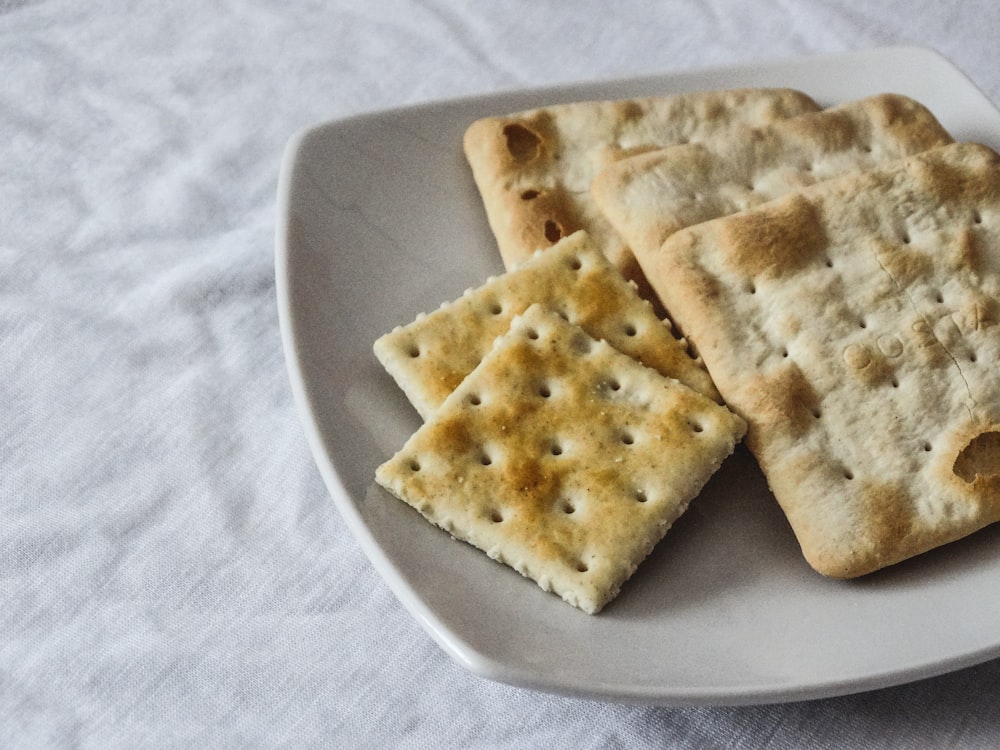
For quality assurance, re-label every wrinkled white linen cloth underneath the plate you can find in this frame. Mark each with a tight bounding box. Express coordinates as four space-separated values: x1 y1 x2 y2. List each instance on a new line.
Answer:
0 0 1000 748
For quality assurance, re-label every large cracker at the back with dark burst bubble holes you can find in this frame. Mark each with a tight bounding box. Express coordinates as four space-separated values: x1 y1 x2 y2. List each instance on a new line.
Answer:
464 89 819 284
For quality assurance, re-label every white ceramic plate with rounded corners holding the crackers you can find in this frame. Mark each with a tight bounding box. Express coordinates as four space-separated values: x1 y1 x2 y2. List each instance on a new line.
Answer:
276 48 1000 705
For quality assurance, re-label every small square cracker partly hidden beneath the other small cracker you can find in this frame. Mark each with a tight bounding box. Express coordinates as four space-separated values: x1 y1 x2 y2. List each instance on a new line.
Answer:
374 231 719 419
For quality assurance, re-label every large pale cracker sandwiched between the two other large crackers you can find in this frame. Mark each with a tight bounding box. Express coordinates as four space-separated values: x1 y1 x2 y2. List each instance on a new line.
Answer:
591 94 952 266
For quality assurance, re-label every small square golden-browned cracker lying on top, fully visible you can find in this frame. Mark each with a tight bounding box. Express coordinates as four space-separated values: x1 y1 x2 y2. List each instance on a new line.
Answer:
376 305 745 613
